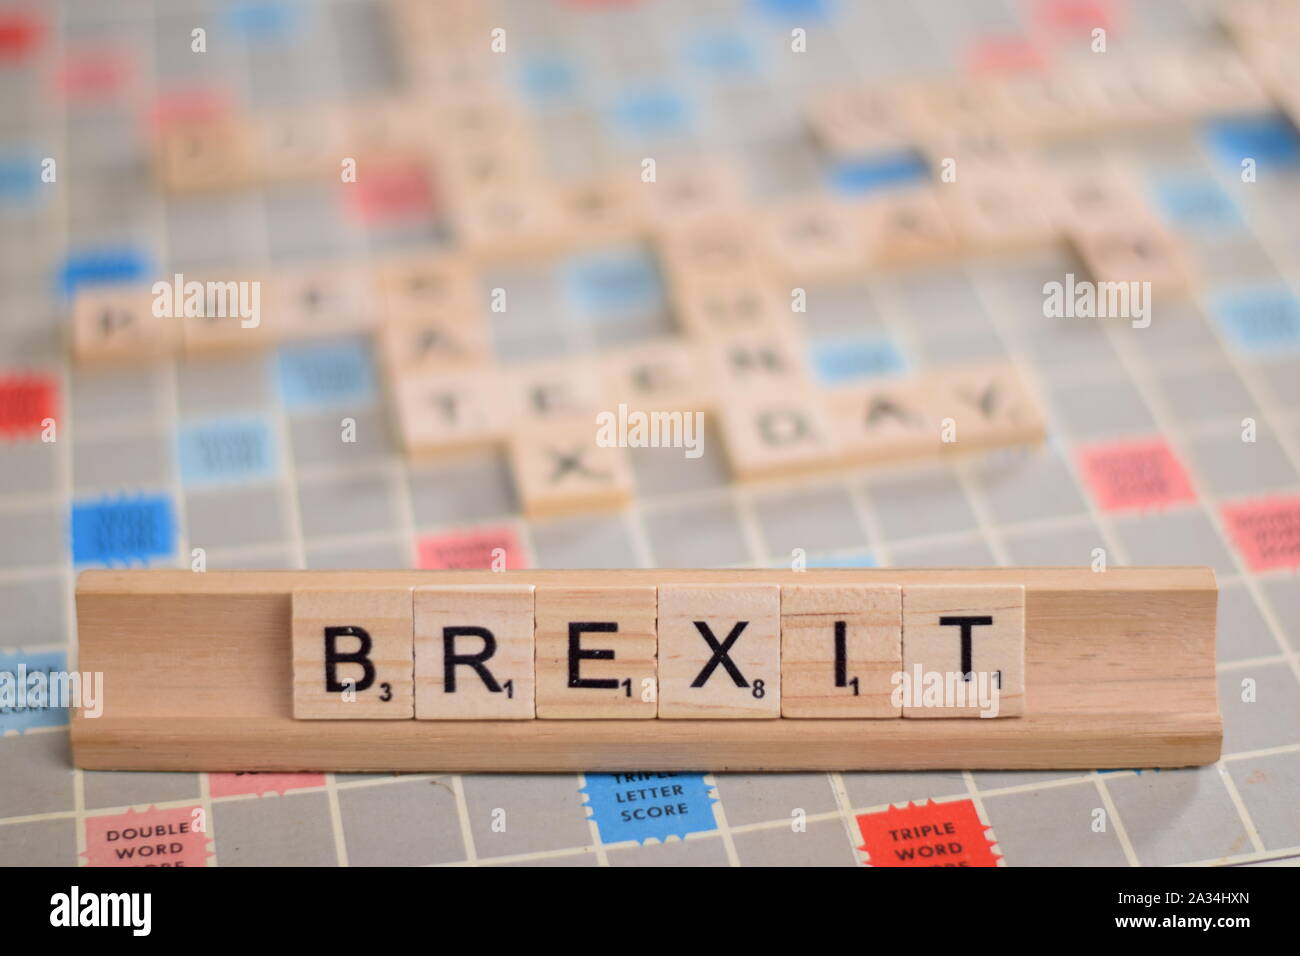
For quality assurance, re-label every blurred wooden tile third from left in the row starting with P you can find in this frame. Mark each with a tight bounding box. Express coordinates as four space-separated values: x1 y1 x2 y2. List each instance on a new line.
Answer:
269 265 380 339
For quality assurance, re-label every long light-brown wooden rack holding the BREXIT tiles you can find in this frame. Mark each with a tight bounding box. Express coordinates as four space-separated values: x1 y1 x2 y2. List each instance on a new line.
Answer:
72 567 1222 771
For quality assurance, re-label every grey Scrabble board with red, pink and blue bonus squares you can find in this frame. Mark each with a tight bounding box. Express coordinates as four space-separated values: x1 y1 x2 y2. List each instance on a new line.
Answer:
0 0 1300 866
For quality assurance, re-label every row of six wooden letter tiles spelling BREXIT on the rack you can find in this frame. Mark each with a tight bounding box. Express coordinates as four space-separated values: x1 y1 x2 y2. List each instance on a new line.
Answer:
293 579 1024 721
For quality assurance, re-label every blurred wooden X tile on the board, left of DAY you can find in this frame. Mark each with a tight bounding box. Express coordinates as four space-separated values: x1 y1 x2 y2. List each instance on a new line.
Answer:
510 418 634 518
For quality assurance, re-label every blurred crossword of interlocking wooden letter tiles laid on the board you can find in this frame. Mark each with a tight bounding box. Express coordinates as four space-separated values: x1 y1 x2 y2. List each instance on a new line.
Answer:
73 1 1300 518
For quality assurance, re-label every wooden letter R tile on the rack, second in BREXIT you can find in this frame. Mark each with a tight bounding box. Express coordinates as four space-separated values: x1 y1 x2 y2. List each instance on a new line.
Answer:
415 584 536 721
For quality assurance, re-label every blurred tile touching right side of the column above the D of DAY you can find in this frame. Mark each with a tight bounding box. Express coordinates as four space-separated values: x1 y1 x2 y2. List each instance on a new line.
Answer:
758 195 867 285
